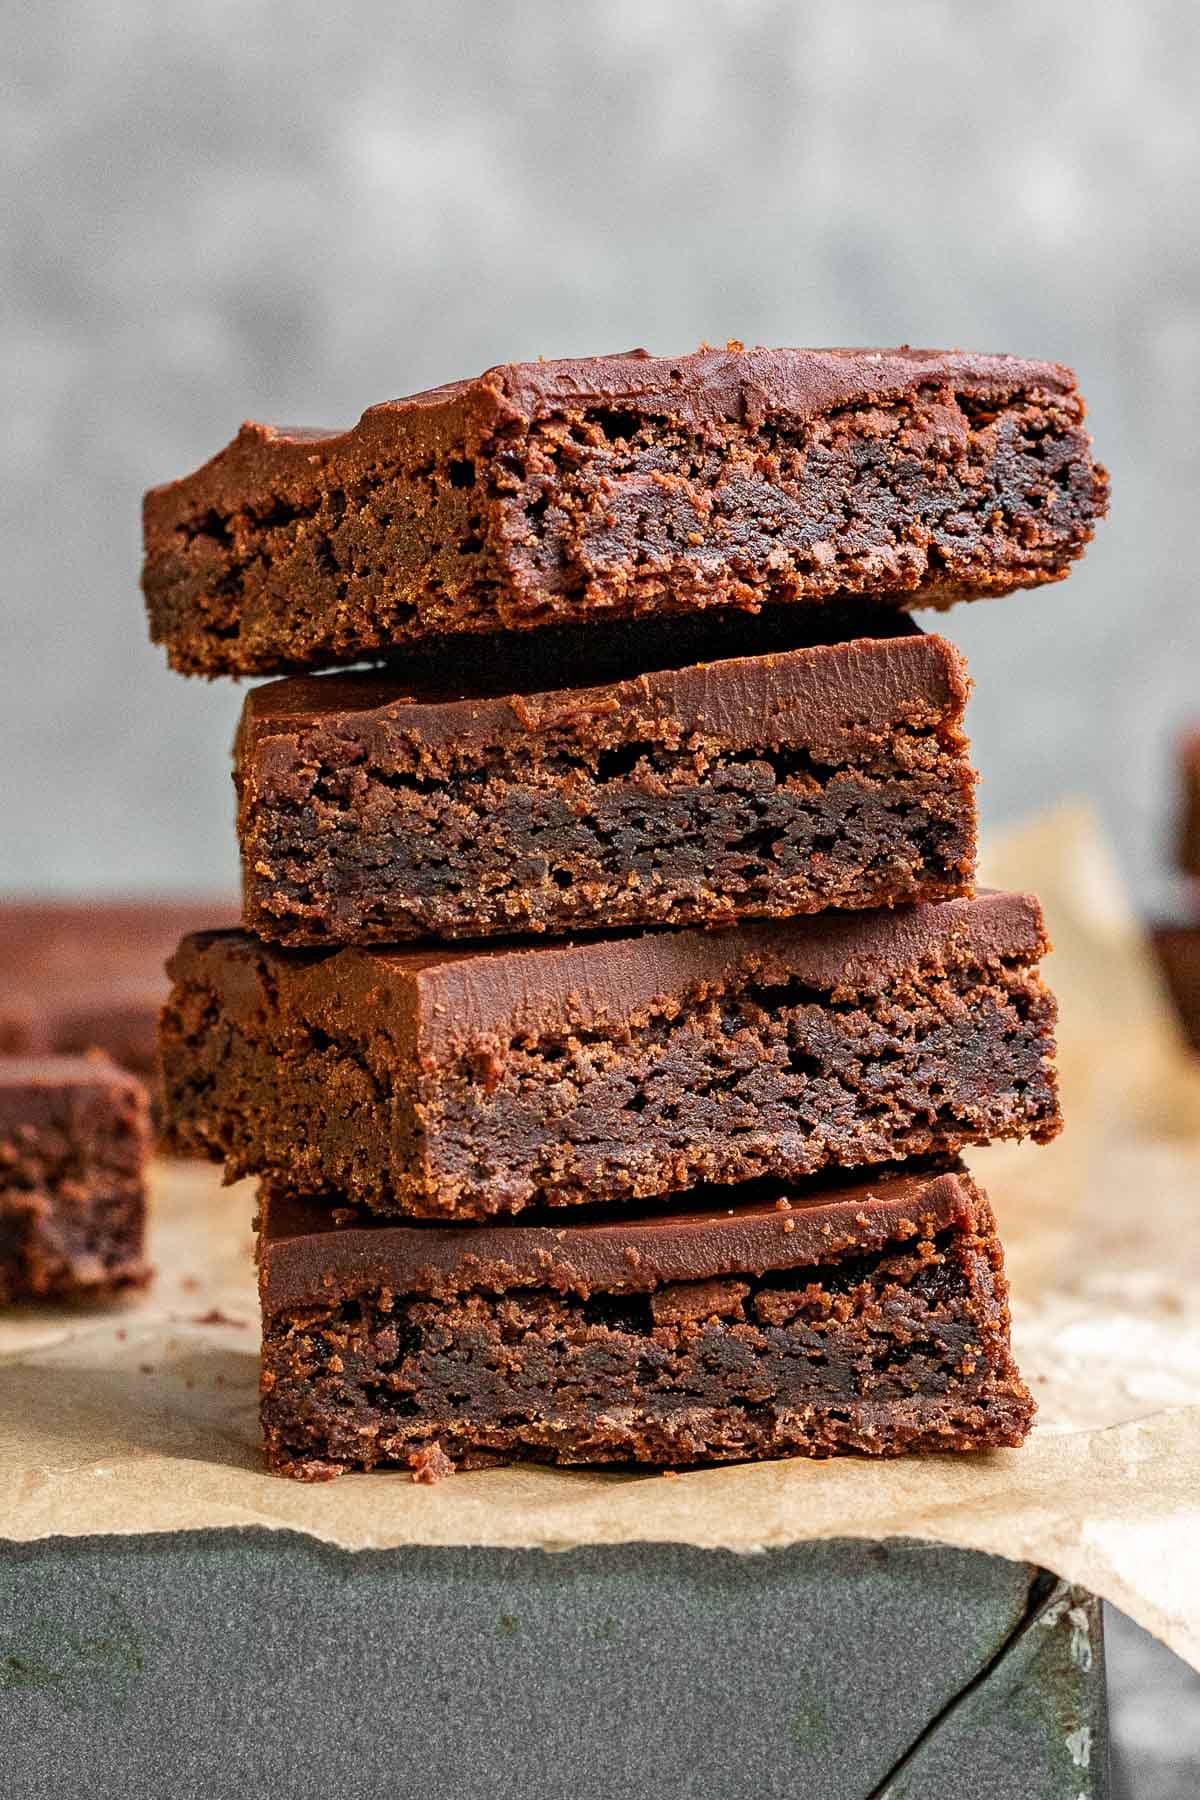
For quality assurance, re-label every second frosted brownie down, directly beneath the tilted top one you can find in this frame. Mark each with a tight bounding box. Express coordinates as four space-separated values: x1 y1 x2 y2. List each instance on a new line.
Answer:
236 608 975 945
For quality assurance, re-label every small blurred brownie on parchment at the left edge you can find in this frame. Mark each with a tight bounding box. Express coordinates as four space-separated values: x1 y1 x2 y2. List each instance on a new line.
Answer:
0 1055 149 1301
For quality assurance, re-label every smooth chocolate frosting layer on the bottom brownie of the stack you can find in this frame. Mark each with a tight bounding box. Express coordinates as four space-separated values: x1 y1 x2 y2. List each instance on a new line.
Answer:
259 1163 982 1319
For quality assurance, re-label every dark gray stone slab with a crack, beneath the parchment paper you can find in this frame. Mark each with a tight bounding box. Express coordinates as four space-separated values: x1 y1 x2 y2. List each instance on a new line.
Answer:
0 1532 1103 1800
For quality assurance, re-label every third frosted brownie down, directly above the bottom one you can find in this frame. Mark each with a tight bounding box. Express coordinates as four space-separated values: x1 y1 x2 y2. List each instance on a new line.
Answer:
162 893 1060 1219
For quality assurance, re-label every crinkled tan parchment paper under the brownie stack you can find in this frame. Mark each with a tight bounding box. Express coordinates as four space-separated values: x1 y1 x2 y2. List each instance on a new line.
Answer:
0 812 1200 1667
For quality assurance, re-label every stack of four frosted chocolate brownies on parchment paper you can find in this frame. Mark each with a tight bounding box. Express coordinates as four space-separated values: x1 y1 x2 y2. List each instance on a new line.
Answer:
144 346 1106 1480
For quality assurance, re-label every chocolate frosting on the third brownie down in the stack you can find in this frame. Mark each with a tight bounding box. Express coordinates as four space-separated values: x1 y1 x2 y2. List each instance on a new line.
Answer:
167 893 1047 1066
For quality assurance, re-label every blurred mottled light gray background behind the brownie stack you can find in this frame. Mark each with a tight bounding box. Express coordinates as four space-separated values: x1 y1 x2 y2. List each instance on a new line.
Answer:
0 0 1200 1800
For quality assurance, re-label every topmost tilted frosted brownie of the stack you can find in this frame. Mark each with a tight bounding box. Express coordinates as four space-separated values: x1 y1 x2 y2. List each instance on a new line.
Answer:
142 344 1108 675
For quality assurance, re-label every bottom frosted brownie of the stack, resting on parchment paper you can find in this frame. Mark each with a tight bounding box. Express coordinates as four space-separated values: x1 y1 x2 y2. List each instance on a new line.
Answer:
259 1168 1033 1480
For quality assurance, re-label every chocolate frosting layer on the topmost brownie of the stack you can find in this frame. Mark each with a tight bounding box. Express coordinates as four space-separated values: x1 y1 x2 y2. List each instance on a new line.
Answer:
146 346 1076 533
